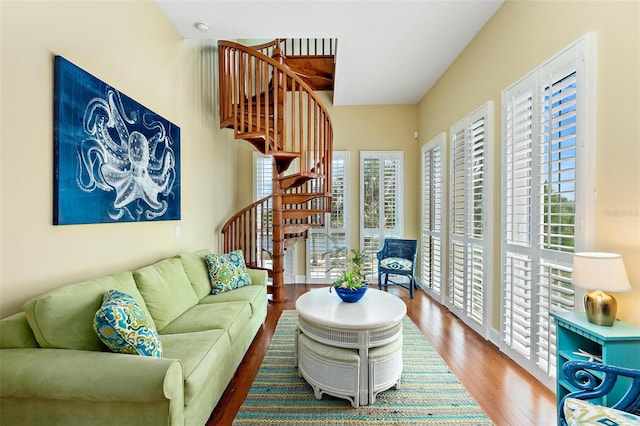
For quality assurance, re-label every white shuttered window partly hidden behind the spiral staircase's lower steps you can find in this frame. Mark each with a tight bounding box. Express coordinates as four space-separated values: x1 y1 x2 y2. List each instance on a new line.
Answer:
307 151 349 284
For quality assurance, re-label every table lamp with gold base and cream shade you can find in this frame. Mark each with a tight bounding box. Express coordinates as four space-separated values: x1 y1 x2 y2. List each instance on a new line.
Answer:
571 252 631 327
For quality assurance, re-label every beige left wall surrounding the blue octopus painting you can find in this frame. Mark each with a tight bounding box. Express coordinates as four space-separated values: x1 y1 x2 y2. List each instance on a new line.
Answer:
0 0 237 316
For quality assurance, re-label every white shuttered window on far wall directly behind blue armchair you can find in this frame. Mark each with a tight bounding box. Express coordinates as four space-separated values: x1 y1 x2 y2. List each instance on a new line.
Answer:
360 151 404 277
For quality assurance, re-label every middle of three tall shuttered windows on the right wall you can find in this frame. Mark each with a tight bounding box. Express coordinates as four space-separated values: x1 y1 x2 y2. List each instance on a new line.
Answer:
447 102 493 336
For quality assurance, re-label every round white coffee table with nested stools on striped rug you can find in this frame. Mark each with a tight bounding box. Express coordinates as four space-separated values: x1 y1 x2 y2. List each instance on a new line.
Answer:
296 287 407 406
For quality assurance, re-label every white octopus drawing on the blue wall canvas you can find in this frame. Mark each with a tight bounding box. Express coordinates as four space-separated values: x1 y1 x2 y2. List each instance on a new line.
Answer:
76 88 176 220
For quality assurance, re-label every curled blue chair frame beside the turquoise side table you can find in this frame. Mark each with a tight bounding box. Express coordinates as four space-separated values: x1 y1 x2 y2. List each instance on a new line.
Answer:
558 361 640 426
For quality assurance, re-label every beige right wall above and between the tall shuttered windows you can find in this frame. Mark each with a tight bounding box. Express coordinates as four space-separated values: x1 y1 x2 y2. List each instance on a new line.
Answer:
418 0 640 329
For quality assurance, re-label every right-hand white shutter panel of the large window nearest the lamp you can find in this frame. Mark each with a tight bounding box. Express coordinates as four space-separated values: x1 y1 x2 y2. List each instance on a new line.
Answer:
535 63 577 377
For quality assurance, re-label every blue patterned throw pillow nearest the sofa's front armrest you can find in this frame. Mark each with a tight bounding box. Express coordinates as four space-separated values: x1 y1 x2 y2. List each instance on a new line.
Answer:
93 290 162 358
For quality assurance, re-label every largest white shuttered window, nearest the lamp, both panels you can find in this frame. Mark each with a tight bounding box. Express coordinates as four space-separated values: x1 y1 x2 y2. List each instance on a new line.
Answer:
501 35 594 387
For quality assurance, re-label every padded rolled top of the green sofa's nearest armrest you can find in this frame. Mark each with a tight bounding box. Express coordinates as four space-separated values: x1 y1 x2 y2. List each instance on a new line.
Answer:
0 348 184 405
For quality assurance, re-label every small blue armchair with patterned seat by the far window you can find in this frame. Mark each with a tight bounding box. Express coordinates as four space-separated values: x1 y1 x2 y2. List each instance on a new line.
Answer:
377 238 418 299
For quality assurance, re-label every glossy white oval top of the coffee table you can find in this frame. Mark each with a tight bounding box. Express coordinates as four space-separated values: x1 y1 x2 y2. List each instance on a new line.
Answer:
296 287 407 330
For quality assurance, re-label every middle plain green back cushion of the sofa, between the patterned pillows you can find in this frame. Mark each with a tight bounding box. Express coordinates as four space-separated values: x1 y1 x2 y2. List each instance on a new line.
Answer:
133 257 198 331
